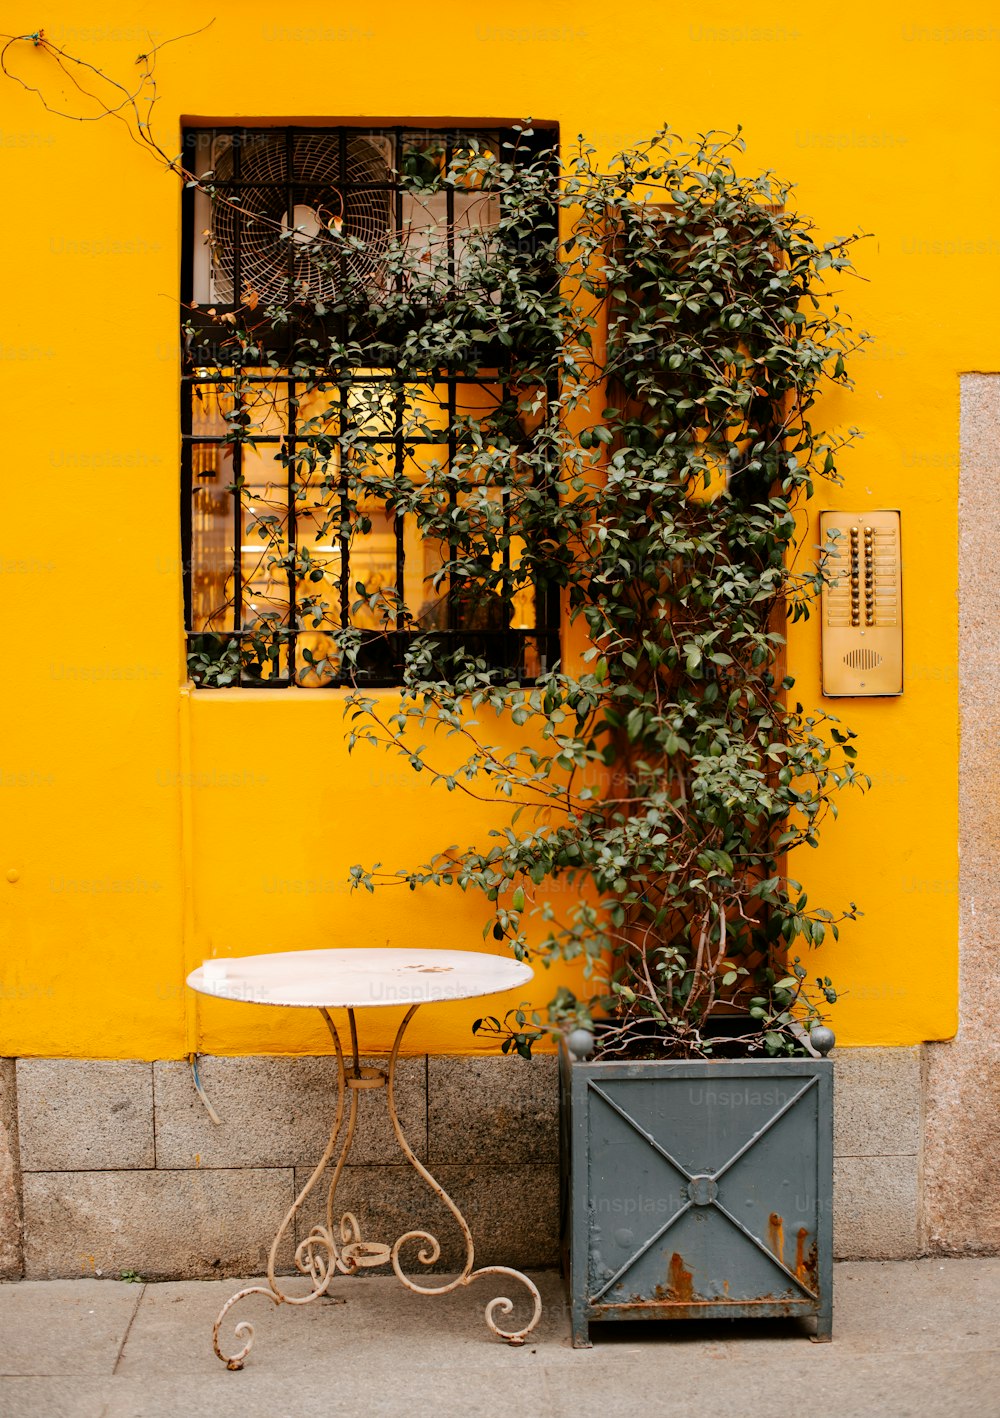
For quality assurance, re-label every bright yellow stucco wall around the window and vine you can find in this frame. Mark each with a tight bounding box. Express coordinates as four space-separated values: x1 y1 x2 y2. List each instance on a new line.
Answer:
0 0 981 1058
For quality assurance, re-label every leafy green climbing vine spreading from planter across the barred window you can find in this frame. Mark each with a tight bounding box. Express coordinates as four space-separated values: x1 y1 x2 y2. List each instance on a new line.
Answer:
3 34 867 1056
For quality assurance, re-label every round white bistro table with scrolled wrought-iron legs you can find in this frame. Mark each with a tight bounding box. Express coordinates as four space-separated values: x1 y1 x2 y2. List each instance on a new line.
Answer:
187 949 542 1368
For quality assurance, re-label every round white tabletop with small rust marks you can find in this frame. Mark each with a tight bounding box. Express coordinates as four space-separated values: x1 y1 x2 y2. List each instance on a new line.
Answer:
187 947 535 1010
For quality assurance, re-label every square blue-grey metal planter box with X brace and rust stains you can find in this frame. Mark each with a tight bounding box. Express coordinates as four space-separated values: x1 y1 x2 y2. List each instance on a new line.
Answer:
560 1051 833 1349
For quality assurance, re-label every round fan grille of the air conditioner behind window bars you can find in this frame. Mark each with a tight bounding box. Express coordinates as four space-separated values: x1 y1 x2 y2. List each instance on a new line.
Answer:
211 132 391 305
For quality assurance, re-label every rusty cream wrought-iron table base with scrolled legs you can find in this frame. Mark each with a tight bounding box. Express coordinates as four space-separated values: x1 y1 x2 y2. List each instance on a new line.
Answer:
213 1004 542 1368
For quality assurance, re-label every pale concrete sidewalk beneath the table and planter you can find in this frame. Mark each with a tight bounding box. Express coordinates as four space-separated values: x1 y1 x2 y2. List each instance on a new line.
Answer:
0 1259 1000 1418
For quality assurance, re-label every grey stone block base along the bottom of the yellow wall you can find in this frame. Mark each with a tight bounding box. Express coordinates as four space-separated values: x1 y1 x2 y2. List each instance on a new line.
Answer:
0 1048 923 1279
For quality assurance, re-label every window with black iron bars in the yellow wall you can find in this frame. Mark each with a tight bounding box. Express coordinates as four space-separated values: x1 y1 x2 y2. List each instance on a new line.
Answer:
182 128 559 689
